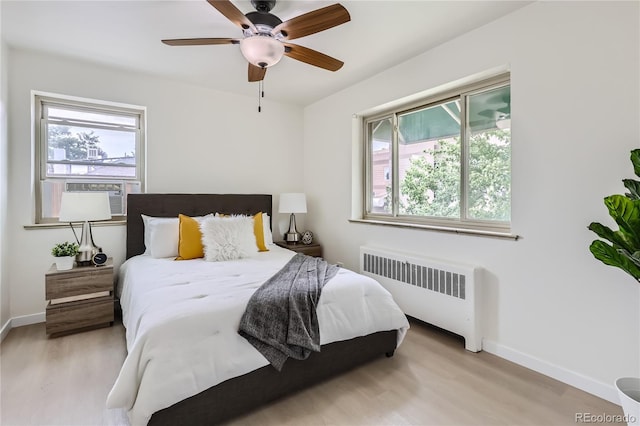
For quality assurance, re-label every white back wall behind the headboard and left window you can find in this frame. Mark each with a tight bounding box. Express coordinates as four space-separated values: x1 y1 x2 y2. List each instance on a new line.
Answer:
3 49 303 318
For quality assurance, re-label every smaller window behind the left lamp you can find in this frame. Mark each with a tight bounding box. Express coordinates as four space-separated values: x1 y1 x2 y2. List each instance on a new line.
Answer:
35 94 145 223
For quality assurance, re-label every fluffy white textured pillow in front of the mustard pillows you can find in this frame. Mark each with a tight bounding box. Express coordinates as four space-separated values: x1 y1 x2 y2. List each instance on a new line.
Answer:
200 216 258 262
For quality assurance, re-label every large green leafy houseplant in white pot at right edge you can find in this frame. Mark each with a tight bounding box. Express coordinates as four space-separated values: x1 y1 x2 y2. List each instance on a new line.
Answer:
589 149 640 425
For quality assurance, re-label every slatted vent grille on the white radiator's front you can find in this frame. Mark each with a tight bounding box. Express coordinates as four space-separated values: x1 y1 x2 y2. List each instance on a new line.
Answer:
363 253 466 300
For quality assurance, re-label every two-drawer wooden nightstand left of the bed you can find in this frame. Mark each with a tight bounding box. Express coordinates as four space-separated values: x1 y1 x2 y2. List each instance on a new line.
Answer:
45 258 114 335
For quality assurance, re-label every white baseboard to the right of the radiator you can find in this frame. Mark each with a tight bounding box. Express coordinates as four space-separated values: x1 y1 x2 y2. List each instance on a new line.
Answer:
482 340 620 405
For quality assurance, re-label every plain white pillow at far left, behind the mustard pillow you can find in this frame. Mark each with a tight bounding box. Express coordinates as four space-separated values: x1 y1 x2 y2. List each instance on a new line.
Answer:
140 213 213 259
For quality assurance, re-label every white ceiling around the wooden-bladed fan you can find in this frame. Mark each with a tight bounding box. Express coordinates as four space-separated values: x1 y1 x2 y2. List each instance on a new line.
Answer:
1 0 531 105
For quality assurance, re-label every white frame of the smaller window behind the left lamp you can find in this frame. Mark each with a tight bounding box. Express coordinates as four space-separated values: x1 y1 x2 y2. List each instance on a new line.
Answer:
32 91 147 224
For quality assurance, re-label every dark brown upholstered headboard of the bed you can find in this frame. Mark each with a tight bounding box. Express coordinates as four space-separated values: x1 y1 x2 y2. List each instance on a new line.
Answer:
127 194 273 259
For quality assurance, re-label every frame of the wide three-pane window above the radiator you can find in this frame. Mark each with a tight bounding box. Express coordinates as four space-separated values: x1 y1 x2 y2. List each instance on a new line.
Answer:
362 72 517 235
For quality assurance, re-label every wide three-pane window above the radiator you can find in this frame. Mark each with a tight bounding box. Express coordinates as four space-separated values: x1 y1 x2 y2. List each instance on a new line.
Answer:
363 75 511 232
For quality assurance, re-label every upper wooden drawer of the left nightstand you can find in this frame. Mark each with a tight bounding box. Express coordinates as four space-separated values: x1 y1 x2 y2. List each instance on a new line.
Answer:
45 266 113 300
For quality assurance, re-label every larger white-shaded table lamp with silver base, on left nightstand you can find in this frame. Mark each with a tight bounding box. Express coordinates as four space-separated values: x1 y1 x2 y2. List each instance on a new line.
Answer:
59 192 111 266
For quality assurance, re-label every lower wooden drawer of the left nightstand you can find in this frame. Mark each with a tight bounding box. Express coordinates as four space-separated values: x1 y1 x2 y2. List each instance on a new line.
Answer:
46 296 113 334
